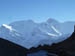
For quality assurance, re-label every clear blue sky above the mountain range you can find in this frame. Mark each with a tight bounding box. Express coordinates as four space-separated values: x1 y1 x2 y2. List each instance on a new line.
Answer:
0 0 75 24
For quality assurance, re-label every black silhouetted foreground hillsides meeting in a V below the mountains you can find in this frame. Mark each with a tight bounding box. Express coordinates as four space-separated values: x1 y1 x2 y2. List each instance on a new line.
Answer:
0 25 75 56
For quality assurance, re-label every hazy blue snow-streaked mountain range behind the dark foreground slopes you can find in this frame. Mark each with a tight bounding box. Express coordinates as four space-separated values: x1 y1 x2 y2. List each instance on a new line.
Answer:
0 19 75 49
